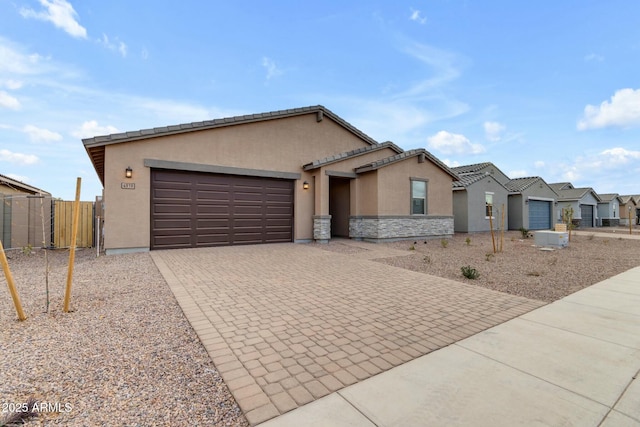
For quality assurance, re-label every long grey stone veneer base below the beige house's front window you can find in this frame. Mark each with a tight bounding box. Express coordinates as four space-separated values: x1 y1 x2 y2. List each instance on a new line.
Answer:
349 216 454 240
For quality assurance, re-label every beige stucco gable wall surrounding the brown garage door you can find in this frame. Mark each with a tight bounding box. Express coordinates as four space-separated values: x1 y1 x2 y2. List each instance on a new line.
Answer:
104 114 369 249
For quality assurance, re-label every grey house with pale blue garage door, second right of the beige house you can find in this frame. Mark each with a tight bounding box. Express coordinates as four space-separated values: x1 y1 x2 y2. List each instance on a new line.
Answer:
505 176 558 230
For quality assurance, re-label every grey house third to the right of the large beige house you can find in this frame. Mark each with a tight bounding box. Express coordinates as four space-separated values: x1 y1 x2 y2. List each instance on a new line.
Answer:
551 182 601 228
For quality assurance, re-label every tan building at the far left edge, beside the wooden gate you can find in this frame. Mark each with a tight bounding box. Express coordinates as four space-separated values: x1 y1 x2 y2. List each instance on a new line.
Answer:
0 175 51 249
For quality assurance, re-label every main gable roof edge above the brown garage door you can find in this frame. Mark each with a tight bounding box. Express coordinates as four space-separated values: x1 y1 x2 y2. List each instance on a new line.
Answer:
82 105 378 184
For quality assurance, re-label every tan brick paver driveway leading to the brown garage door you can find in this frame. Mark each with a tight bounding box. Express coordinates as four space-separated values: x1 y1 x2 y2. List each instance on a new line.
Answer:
151 241 544 424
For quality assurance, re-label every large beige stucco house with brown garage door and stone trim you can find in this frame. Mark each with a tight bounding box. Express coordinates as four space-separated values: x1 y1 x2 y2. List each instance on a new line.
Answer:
83 106 458 253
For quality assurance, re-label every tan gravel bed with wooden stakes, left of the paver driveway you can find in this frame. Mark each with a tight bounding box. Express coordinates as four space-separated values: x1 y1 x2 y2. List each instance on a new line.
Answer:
0 249 248 426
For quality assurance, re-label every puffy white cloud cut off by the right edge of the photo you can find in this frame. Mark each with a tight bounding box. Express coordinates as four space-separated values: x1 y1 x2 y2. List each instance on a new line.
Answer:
578 88 640 130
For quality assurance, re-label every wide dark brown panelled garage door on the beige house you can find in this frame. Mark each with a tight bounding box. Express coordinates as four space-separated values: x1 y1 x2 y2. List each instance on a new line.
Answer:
151 169 293 249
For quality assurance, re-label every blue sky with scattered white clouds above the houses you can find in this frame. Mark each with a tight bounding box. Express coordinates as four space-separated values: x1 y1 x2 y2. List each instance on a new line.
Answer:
0 0 640 200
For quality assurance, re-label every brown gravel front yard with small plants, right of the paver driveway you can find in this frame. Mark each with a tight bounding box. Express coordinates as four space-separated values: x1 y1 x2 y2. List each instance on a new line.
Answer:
377 229 640 302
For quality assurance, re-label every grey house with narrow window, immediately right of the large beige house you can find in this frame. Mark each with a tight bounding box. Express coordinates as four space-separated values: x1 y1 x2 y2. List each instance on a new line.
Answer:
451 163 509 233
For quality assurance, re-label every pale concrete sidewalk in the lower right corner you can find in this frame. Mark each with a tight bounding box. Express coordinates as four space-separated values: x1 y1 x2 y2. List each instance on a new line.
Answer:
261 267 640 427
